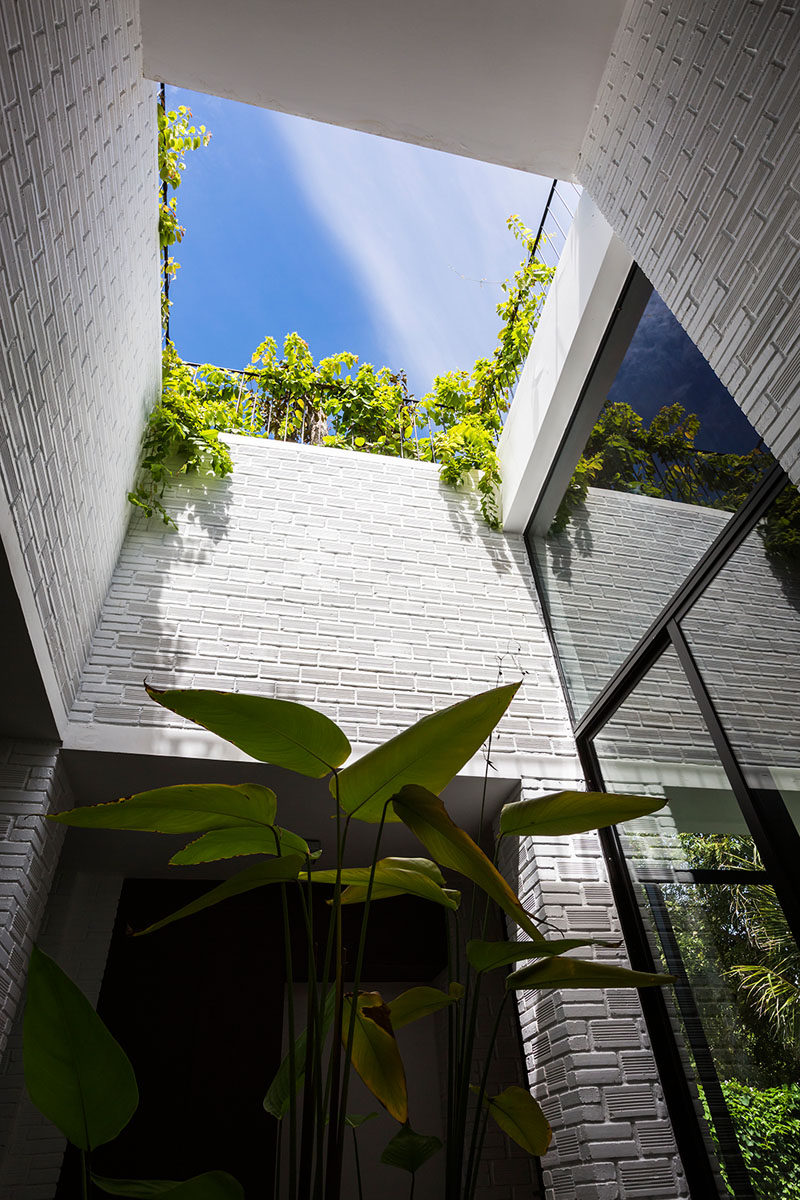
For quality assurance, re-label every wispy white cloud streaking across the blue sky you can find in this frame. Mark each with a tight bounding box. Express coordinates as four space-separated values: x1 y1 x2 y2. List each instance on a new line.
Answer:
264 113 549 394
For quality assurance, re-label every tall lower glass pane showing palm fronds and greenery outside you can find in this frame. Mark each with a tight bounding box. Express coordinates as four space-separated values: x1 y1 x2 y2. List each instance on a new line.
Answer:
595 650 800 1200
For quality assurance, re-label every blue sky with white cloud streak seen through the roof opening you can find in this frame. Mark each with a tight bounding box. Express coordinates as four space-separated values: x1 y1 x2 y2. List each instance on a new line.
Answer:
167 88 551 395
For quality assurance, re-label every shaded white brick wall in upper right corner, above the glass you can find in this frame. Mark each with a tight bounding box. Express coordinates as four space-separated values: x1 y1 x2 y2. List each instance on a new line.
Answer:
577 0 800 481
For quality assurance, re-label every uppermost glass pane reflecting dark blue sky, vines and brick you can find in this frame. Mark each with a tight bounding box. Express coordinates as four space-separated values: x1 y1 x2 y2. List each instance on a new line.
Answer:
529 293 772 715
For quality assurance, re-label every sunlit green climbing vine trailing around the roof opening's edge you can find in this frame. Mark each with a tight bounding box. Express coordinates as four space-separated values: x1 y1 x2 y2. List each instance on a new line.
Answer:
128 106 553 528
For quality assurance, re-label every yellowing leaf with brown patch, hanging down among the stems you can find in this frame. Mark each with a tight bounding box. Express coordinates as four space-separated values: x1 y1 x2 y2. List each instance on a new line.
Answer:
342 991 408 1124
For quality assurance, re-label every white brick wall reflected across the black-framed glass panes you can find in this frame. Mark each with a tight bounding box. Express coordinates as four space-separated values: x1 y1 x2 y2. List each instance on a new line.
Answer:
536 488 800 768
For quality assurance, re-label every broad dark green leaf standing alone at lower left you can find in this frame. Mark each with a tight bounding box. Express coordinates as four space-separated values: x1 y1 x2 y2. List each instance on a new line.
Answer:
23 946 139 1150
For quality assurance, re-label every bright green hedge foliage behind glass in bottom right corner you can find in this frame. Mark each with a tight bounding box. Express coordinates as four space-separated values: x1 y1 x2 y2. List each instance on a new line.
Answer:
700 1080 800 1200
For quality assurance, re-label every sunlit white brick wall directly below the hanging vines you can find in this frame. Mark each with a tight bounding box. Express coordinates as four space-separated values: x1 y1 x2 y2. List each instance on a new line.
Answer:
72 438 575 756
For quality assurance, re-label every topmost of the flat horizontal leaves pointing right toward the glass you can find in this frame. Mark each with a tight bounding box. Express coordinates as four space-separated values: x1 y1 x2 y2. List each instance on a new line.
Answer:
500 792 667 838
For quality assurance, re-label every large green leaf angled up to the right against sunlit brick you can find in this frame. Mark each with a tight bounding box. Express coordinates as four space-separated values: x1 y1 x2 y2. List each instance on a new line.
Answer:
331 683 519 823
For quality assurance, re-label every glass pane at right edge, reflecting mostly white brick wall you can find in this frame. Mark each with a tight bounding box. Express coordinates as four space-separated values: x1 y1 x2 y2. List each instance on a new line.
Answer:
682 486 800 824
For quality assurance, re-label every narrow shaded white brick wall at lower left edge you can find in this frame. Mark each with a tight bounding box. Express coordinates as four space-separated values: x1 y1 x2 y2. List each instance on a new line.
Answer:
0 740 72 1057
